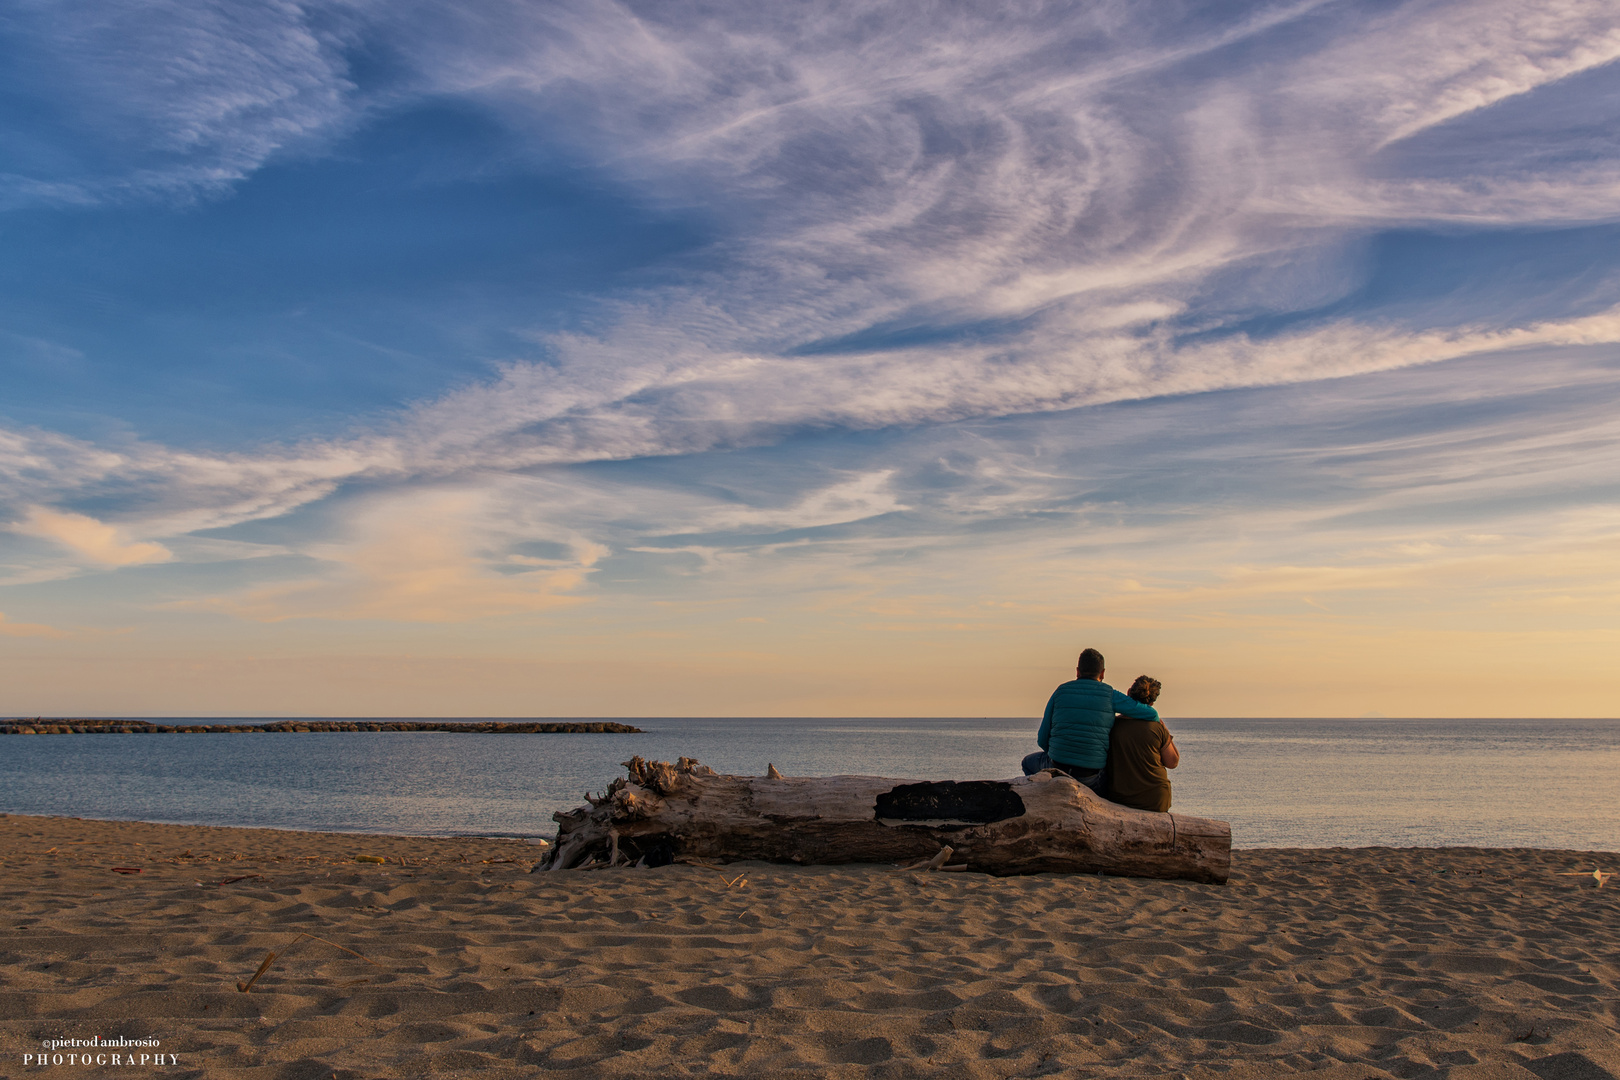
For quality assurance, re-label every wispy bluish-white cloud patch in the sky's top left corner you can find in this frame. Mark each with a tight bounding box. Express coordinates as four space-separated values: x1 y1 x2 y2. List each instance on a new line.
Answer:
0 0 356 207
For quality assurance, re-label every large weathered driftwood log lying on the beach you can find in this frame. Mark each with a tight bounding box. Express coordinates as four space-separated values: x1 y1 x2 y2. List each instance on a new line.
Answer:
536 758 1231 882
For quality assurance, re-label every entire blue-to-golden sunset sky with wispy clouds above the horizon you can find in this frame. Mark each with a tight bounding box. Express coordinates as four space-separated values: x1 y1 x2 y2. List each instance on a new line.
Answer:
0 0 1620 717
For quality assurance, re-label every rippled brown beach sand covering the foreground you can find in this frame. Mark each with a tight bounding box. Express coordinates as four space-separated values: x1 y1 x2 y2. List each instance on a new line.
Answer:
0 816 1620 1080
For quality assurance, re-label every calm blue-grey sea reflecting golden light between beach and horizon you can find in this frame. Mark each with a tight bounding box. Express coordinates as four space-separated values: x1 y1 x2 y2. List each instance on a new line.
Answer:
0 717 1620 852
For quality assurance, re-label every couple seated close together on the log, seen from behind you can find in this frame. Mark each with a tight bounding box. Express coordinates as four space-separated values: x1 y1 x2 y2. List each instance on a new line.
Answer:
1024 649 1181 813
